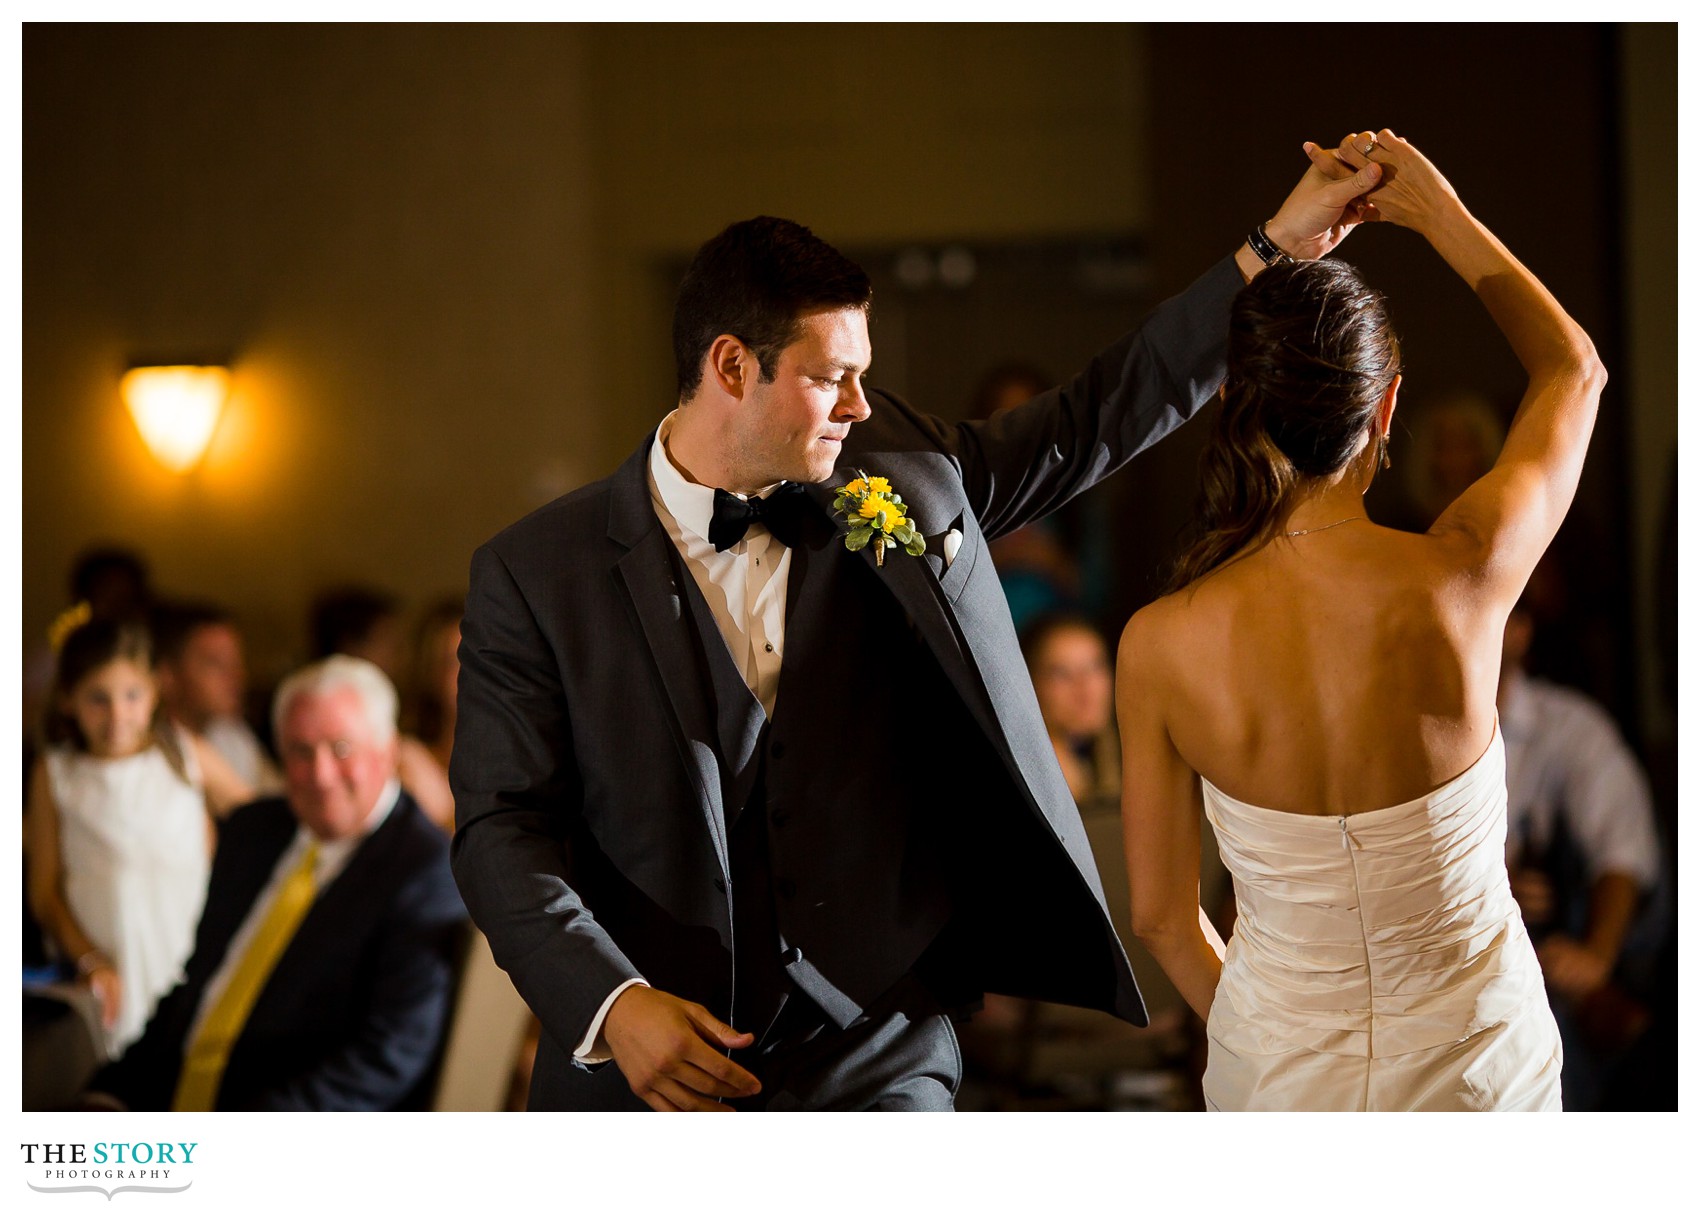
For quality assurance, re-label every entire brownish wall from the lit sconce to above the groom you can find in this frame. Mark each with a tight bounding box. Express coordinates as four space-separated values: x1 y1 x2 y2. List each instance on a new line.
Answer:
22 25 1146 674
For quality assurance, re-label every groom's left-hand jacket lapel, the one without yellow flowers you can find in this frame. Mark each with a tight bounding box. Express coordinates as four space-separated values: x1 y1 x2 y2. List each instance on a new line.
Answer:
609 438 731 873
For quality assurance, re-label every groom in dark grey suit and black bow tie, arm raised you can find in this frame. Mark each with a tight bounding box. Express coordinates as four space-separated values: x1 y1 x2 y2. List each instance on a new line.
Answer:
451 144 1375 1111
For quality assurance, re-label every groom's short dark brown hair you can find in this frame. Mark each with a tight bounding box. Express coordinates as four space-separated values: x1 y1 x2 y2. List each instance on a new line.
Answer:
673 214 874 401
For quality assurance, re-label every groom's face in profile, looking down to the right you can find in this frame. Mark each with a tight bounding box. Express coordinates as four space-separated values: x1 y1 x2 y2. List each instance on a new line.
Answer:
733 307 874 484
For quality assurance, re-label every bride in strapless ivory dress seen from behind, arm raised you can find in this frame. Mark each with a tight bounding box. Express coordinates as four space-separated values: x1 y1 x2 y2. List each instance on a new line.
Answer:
1117 131 1605 1109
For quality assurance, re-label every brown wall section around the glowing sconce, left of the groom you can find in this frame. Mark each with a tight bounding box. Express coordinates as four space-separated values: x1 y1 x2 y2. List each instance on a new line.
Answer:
24 27 600 679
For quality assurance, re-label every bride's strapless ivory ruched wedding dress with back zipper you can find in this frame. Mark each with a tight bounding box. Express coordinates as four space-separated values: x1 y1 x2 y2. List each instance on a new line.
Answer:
1204 729 1562 1111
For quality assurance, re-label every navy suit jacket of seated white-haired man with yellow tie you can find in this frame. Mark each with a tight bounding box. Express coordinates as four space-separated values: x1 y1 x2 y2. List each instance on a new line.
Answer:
94 792 468 1111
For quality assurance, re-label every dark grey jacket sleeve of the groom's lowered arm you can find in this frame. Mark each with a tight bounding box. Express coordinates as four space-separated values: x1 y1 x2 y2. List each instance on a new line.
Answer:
449 545 641 1052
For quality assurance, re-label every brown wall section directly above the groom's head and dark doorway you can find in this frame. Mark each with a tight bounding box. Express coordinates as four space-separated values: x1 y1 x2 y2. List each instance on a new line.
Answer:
590 24 1149 450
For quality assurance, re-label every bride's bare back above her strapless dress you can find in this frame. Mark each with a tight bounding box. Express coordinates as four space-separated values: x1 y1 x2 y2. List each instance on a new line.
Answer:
1142 518 1499 815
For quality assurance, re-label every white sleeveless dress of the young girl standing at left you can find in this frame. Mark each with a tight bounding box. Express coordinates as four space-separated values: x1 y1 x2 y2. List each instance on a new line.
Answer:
48 742 211 1057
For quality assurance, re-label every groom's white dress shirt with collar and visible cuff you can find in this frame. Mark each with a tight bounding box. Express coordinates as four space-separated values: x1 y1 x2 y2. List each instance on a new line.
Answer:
573 413 791 1063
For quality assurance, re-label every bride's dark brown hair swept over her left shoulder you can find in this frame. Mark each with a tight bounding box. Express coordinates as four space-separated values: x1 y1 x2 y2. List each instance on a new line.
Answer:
1165 260 1399 593
